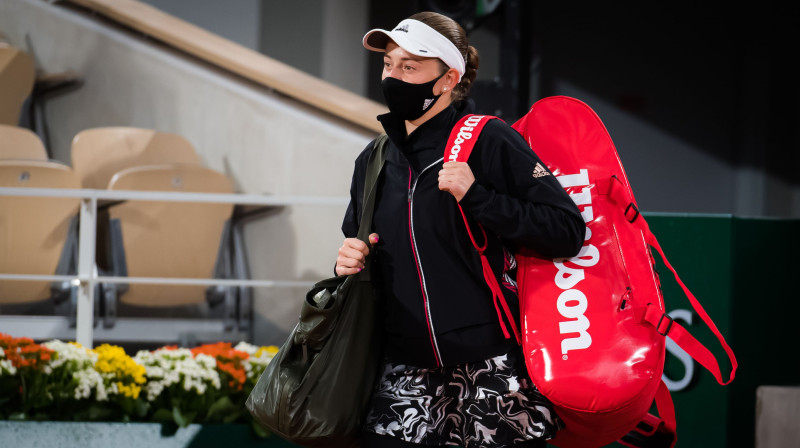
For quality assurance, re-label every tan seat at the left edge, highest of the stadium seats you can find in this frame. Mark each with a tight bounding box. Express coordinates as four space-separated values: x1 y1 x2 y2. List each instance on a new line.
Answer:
0 42 36 126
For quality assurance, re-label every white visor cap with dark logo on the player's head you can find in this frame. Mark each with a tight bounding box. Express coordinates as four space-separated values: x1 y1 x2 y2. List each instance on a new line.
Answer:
362 19 466 81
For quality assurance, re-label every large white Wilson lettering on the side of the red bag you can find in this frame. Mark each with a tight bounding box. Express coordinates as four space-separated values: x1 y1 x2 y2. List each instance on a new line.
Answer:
553 170 600 359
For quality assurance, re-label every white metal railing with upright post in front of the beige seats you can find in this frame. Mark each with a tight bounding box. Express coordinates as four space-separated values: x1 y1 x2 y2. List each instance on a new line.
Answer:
0 187 349 347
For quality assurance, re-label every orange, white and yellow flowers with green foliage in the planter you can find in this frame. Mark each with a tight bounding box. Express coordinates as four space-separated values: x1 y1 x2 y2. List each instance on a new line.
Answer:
0 333 283 438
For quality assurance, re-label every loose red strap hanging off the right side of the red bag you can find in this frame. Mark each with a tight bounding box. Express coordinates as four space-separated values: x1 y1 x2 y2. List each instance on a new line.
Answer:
608 176 738 386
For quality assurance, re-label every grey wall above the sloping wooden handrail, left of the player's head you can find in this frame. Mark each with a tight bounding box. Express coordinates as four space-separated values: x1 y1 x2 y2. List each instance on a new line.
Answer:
143 0 372 95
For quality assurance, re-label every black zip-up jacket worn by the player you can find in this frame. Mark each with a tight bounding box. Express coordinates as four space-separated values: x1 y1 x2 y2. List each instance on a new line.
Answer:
342 101 586 367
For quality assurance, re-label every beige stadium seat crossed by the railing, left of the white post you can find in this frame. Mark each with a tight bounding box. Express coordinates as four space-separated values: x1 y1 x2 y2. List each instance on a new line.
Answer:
0 160 80 304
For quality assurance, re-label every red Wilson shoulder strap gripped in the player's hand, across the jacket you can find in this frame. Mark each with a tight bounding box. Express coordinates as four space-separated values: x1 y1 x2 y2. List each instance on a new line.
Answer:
444 115 522 344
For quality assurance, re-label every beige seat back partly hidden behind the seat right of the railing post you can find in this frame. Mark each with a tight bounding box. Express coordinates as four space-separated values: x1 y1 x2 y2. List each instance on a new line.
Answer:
72 127 201 190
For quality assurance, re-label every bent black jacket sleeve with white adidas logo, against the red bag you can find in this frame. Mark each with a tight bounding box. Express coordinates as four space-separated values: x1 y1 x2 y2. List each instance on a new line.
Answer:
461 120 586 258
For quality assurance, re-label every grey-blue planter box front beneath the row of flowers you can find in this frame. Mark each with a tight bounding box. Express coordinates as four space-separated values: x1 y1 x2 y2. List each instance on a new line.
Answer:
0 420 297 448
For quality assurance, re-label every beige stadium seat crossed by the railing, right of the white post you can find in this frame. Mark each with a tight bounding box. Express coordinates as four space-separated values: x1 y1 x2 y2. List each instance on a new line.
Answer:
104 164 233 317
